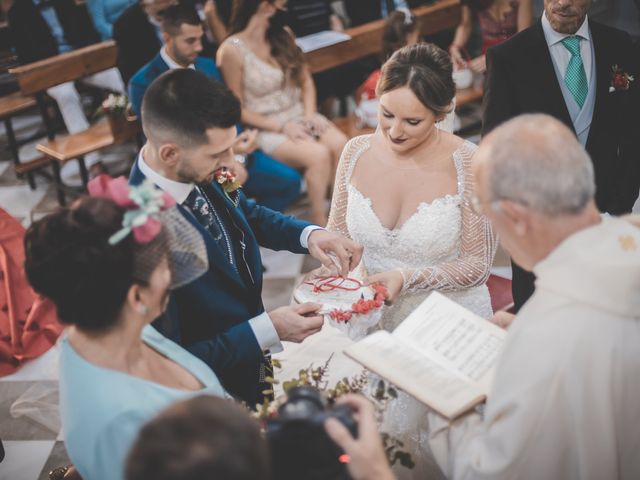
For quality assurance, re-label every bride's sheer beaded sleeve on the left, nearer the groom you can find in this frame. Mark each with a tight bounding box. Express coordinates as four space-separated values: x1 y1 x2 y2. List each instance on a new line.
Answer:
327 135 370 238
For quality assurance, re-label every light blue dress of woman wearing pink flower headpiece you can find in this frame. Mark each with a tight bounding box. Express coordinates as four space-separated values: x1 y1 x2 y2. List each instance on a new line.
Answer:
60 325 225 480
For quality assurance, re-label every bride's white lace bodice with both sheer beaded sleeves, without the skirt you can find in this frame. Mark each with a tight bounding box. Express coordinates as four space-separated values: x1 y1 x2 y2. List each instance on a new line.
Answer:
328 135 496 293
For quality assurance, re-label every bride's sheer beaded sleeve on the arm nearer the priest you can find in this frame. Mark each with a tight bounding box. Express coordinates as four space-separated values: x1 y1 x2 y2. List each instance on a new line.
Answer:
401 144 497 291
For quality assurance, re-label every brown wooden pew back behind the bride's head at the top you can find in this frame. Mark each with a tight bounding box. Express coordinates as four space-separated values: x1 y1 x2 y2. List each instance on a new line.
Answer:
305 0 462 73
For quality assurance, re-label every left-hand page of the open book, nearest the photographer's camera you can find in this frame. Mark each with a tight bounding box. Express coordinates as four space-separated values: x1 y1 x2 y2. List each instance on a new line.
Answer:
344 331 483 418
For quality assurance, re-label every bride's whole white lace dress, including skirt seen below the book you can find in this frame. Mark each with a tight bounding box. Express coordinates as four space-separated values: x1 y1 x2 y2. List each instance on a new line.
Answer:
327 135 497 479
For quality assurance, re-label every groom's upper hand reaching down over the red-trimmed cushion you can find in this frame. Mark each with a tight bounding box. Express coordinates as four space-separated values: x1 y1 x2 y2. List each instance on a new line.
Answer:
308 229 362 277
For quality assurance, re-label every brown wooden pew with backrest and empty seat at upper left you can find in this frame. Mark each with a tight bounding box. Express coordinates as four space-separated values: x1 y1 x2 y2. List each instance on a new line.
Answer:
10 40 137 205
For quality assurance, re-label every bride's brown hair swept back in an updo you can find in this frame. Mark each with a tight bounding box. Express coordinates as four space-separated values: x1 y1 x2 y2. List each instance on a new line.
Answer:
376 43 456 117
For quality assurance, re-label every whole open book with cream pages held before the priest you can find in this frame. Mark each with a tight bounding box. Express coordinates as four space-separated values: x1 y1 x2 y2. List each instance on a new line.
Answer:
344 292 507 419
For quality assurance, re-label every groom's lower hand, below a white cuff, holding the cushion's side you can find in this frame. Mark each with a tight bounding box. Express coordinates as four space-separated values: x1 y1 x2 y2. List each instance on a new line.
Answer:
269 303 324 343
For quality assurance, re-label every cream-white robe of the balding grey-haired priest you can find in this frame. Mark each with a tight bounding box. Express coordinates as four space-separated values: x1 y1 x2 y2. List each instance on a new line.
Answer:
429 218 640 480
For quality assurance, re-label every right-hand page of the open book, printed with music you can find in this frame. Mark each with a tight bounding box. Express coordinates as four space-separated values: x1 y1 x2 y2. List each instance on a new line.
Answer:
393 292 506 394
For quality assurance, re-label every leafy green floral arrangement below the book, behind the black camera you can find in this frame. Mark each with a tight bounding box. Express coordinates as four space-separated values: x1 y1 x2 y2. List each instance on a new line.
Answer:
250 355 414 468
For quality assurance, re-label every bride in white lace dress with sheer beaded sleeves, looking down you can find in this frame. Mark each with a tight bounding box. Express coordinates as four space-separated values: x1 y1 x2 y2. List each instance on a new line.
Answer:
327 44 496 478
